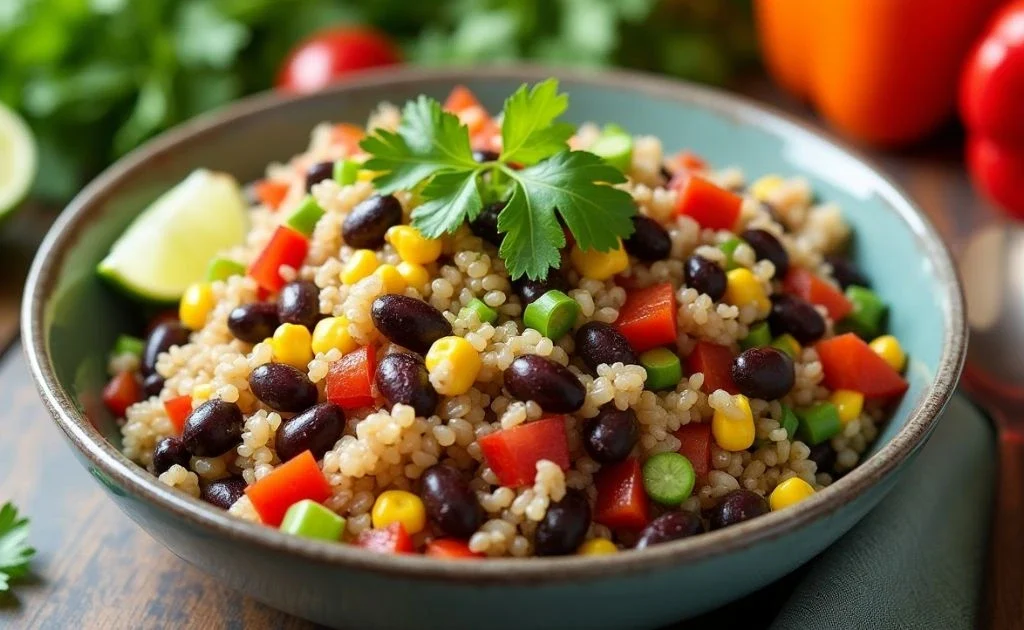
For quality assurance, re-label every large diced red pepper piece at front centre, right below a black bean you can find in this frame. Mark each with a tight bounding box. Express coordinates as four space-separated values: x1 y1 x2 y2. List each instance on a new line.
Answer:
477 416 571 488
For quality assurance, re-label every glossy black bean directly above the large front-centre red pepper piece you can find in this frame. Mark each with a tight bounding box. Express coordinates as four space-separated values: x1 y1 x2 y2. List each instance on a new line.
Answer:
505 354 587 414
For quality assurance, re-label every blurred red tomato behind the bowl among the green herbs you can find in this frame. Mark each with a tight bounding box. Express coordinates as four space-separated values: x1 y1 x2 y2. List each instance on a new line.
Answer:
276 27 401 94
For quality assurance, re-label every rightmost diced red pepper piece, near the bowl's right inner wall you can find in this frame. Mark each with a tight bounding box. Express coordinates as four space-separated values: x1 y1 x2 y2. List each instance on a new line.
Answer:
814 333 908 398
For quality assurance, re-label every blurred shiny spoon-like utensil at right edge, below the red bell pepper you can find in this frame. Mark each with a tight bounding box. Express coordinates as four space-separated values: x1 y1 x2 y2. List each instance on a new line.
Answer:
961 224 1024 630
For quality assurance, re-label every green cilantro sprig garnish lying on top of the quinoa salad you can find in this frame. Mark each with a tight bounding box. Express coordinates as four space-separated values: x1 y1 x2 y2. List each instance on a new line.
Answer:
360 79 636 280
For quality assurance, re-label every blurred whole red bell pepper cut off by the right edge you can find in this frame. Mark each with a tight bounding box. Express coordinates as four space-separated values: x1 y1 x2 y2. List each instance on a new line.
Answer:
959 0 1024 218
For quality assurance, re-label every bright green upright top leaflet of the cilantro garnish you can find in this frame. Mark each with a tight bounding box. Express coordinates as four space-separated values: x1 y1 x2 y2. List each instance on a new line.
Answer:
500 79 575 164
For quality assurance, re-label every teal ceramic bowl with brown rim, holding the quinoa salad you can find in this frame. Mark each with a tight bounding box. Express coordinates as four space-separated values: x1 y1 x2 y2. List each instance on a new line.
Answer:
23 68 966 630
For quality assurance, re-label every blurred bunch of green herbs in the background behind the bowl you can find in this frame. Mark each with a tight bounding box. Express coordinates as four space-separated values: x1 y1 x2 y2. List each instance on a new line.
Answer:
0 0 755 201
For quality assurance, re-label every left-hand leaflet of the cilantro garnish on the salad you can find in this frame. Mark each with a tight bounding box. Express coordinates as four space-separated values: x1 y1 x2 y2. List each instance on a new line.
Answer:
359 95 478 194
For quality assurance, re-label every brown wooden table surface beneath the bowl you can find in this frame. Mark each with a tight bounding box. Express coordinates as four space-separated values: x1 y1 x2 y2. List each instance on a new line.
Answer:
0 84 993 629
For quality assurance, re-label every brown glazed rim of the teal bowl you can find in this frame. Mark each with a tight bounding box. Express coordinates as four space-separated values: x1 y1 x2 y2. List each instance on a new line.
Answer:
22 65 967 586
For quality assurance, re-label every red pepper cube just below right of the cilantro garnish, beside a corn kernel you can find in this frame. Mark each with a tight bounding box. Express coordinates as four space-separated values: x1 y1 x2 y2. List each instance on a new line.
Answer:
615 283 678 352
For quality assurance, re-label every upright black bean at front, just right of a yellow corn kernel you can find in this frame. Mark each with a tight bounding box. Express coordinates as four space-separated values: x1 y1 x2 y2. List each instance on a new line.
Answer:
420 464 484 538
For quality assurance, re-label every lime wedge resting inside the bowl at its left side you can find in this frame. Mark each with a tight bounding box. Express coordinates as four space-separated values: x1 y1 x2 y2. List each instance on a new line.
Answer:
96 169 248 302
